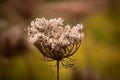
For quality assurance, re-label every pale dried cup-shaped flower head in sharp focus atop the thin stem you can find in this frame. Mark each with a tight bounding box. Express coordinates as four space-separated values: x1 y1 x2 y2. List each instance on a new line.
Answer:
27 18 84 80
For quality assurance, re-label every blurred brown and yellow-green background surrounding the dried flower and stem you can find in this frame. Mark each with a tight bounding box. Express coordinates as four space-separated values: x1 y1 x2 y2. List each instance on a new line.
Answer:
0 0 120 80
